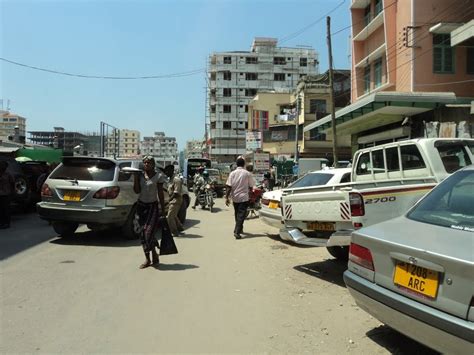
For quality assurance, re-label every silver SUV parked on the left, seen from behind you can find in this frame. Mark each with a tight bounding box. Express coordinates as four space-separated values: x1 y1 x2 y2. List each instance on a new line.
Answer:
37 157 189 239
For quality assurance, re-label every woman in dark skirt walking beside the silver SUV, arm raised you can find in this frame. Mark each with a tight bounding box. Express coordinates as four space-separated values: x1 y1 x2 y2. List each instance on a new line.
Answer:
133 156 166 269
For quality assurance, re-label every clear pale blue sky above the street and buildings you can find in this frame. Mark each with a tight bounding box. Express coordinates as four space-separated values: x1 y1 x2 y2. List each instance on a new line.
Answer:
0 0 351 150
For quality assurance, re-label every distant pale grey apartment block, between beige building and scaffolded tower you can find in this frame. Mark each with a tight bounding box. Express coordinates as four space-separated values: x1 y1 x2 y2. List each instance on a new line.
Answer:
140 132 179 166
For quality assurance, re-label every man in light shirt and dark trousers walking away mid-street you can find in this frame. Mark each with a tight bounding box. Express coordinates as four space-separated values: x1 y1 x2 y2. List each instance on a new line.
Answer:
225 157 255 239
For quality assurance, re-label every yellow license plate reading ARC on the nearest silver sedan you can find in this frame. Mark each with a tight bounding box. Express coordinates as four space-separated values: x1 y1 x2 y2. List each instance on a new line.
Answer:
393 263 438 298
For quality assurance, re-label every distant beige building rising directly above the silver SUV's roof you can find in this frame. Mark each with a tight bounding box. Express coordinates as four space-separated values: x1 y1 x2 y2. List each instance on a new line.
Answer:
105 129 140 158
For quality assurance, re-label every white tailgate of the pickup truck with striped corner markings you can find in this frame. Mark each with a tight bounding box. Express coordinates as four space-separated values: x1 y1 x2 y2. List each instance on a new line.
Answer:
282 190 351 222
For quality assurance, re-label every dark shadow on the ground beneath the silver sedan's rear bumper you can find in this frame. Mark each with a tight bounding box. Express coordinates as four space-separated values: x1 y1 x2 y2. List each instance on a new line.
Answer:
366 325 439 355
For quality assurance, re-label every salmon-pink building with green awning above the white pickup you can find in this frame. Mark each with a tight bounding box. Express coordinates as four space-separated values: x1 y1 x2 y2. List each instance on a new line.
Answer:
305 0 474 150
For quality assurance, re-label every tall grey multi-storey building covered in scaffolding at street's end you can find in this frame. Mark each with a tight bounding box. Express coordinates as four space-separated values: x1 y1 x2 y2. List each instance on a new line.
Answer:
206 37 318 162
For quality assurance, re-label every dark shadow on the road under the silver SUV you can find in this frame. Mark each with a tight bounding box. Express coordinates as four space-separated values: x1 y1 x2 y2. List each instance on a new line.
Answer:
50 231 140 247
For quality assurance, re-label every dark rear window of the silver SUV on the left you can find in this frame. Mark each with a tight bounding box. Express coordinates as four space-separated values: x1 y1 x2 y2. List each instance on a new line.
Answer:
49 159 115 181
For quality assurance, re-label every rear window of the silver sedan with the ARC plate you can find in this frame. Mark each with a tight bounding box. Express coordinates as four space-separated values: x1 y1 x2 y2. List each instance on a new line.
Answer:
407 170 474 232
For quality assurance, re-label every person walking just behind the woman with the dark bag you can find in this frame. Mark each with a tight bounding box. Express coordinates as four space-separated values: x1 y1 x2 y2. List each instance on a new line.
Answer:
165 165 184 237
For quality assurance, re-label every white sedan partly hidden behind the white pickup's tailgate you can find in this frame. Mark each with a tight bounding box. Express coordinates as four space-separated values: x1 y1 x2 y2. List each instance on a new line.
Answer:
259 168 351 230
